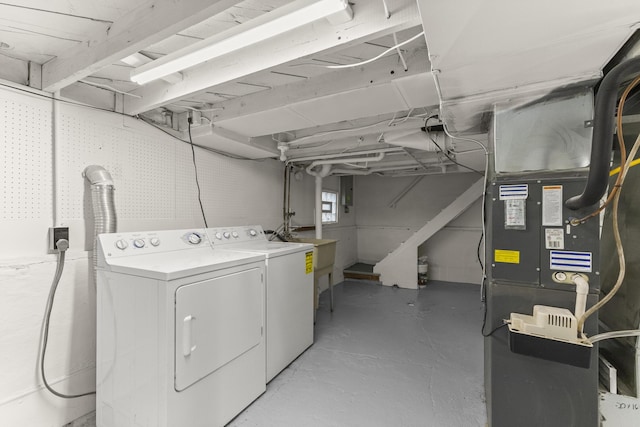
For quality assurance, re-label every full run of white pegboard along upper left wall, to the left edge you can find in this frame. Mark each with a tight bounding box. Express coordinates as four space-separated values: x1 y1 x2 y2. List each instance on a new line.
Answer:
0 85 302 250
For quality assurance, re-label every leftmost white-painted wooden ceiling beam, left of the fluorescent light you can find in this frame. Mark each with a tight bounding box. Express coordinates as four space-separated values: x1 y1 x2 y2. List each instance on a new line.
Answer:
42 0 241 92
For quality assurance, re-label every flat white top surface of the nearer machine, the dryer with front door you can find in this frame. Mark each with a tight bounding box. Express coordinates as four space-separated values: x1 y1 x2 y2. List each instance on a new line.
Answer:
105 246 265 281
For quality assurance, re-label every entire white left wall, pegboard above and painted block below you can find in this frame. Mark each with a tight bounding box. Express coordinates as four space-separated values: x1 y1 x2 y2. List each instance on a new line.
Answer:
0 85 356 427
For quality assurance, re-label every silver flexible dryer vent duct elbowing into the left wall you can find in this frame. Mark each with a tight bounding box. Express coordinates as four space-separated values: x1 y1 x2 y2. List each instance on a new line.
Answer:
82 165 117 283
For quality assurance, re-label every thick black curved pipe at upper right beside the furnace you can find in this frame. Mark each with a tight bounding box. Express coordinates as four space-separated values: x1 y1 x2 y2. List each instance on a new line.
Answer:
565 57 640 210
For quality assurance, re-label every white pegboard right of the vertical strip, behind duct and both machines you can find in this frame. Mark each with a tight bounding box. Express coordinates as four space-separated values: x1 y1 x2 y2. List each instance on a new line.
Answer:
60 105 283 229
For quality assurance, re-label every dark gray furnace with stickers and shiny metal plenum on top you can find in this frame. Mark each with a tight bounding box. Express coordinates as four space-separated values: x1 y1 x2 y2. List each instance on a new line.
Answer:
483 88 600 427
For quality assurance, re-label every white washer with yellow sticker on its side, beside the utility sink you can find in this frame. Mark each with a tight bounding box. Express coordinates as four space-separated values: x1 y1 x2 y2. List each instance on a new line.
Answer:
207 225 314 382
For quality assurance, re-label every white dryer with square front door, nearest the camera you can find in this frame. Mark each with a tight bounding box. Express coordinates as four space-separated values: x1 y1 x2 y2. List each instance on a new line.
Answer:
96 230 266 427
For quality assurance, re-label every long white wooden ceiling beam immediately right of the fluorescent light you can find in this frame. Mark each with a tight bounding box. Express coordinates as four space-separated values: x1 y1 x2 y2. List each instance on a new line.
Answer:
126 0 422 114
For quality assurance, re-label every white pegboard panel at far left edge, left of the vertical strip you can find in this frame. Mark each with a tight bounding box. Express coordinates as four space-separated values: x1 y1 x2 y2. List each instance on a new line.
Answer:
0 92 52 221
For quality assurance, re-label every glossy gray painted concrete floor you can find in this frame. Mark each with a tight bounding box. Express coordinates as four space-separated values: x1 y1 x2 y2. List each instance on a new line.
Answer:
229 281 486 427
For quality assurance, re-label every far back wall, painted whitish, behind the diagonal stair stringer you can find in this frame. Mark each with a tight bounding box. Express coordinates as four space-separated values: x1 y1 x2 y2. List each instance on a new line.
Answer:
354 173 482 284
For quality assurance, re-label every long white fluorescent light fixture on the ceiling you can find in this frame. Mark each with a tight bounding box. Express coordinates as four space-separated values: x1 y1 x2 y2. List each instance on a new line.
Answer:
131 0 353 84
